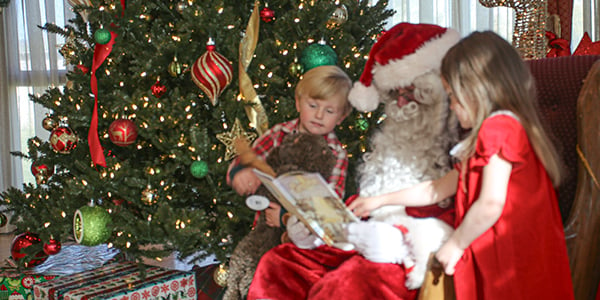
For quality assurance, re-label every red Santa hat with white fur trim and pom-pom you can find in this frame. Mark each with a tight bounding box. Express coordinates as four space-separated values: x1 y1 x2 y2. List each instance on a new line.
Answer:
348 23 460 111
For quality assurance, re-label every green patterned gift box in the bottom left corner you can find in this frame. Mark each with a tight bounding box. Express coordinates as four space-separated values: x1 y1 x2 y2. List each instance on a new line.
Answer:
0 268 56 300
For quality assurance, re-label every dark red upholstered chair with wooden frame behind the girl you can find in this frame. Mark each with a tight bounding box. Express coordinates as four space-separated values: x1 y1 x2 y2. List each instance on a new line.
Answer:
527 56 600 300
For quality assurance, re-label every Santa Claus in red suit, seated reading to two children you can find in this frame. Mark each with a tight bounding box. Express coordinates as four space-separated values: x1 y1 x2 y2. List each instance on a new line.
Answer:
248 23 459 300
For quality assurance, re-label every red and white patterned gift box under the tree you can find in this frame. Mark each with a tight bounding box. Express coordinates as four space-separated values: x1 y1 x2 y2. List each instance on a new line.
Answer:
34 262 197 300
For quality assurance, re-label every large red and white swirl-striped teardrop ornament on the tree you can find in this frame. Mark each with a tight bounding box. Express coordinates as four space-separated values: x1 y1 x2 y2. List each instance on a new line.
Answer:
192 38 233 106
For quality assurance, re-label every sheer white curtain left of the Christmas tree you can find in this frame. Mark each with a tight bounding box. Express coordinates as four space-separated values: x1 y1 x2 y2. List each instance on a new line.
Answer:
0 0 73 197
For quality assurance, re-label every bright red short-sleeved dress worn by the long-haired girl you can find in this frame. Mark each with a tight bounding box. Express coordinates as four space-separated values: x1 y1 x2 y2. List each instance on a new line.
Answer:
454 114 573 300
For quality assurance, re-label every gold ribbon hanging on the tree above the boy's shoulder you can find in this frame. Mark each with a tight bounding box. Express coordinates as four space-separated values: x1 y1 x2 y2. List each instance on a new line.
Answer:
238 1 269 135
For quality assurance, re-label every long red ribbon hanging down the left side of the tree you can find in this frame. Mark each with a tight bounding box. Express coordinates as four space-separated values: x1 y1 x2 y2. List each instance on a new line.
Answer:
88 31 117 167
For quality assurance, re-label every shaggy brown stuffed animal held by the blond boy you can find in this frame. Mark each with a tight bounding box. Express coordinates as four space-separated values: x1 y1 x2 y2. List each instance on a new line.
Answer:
223 133 336 300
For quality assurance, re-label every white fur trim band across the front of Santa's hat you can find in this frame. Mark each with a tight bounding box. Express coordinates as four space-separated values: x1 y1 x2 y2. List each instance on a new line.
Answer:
373 28 460 90
